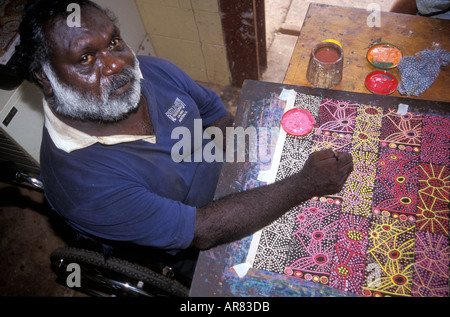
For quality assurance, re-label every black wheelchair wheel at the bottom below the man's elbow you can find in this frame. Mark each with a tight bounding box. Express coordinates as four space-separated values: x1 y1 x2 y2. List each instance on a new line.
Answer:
50 247 189 297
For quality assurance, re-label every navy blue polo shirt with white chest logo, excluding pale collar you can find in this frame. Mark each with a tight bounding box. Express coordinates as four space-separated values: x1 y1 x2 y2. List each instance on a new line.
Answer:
41 56 226 250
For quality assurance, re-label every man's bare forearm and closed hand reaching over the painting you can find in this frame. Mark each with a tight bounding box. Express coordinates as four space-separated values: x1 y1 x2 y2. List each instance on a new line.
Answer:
192 150 353 249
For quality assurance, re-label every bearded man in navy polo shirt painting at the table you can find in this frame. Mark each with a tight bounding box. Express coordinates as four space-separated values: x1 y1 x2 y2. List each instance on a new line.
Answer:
18 0 353 284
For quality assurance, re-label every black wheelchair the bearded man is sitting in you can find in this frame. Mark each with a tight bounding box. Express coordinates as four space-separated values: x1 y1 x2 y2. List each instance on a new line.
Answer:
0 162 190 297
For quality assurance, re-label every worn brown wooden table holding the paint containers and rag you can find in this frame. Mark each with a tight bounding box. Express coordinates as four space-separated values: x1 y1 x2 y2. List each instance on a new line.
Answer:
284 3 450 102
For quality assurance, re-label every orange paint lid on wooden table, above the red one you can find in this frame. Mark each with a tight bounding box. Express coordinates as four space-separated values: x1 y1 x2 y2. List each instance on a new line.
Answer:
367 43 403 69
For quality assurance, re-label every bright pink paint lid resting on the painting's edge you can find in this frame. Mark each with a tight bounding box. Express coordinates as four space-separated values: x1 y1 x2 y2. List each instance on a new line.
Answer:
281 108 315 136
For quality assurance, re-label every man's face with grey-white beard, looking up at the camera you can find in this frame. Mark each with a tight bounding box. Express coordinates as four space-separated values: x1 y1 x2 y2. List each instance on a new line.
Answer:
43 6 140 122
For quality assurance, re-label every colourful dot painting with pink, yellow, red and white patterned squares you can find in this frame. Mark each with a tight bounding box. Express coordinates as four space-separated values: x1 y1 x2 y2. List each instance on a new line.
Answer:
254 94 450 297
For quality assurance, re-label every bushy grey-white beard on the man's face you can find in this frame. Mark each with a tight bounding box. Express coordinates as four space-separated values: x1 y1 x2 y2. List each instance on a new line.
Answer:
43 57 141 122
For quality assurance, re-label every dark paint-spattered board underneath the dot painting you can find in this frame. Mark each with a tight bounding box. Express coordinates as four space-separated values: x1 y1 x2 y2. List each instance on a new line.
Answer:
190 81 450 297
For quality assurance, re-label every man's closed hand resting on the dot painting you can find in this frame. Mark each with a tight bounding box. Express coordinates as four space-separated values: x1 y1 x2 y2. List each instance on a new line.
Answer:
298 150 353 196
